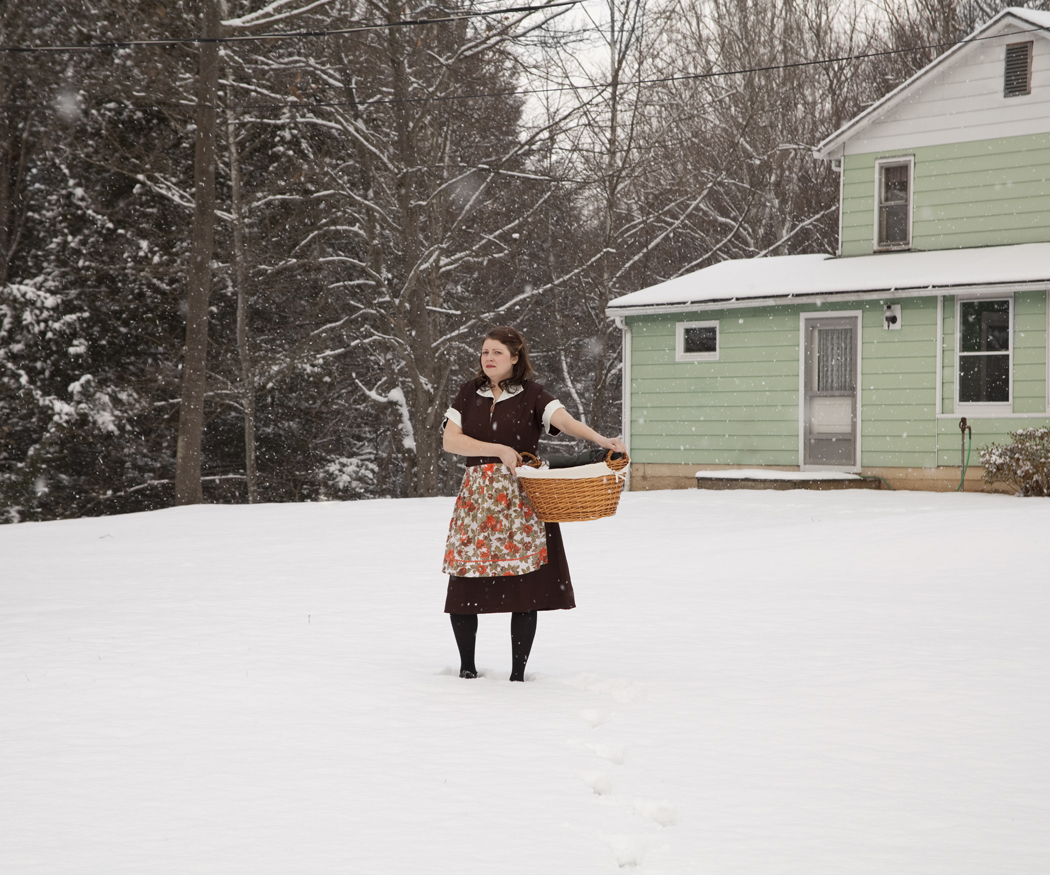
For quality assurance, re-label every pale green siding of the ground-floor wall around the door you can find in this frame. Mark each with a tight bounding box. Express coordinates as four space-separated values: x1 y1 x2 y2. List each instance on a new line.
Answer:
629 292 1047 467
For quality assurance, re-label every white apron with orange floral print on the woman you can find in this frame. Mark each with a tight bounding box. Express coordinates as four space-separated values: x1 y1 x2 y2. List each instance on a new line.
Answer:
442 462 547 578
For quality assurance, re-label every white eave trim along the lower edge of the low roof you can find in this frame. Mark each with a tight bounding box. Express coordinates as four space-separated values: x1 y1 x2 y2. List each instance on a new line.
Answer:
605 279 1048 319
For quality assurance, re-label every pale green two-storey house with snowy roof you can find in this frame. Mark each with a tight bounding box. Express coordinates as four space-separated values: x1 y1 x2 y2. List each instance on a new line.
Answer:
606 8 1050 489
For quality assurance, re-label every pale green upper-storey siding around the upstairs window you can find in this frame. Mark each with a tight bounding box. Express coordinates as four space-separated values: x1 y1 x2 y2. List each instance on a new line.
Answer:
841 133 1050 255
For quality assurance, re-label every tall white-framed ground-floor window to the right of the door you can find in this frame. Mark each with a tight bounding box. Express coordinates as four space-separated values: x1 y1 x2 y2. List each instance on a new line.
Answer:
959 298 1011 404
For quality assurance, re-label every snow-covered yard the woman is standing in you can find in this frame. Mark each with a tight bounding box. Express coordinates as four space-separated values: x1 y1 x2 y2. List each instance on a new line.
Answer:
0 491 1050 875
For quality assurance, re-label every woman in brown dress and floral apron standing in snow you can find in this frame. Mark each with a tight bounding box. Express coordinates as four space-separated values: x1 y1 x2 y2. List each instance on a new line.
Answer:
442 328 627 681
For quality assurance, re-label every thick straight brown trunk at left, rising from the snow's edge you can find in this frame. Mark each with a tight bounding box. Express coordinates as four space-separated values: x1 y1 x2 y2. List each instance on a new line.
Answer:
175 0 219 504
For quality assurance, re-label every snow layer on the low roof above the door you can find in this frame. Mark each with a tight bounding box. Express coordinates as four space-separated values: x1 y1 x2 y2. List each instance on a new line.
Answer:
606 243 1050 315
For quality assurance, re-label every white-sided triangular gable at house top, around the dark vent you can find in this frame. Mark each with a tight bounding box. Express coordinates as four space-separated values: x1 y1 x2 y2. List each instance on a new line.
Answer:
817 9 1050 159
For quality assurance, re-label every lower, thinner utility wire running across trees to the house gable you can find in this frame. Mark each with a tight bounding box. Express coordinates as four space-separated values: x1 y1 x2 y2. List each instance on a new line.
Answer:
8 22 1050 110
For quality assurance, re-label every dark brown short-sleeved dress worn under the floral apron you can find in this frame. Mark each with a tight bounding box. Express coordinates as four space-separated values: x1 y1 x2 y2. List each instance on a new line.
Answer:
445 380 575 613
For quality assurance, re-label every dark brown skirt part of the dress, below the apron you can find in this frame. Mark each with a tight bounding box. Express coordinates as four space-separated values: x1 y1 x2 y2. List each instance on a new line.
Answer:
445 523 576 613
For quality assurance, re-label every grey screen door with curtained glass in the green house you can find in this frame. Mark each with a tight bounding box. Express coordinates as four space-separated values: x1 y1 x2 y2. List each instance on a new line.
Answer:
801 316 858 467
